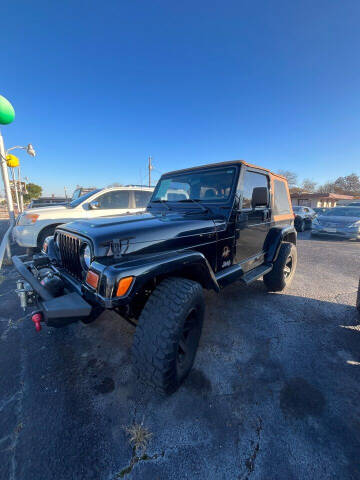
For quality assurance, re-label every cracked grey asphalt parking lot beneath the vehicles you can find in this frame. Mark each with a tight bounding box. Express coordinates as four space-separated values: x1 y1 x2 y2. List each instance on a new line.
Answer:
0 222 360 480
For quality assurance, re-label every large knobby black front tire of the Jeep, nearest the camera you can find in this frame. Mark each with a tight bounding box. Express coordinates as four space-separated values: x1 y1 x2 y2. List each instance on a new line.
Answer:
132 277 205 394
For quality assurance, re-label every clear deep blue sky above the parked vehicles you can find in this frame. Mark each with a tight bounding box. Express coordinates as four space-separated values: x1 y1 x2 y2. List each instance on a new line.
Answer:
0 0 360 194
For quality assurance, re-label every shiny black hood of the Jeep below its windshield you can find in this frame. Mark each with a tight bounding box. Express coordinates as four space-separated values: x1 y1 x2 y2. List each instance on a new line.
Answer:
60 211 215 256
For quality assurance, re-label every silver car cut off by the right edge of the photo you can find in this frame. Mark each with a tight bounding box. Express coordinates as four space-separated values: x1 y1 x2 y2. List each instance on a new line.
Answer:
311 207 360 240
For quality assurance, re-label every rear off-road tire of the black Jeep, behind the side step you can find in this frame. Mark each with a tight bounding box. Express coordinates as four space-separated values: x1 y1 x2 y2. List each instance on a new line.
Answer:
264 242 297 292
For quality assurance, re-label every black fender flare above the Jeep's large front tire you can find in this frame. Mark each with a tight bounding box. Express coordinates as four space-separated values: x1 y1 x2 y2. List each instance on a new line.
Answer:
102 250 220 297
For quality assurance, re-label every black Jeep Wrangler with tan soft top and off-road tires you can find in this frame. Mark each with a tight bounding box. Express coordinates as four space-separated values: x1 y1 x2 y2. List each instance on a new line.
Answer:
13 161 297 393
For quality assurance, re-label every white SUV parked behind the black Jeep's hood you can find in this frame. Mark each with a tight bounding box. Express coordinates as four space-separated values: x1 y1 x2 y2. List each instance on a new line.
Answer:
13 187 153 248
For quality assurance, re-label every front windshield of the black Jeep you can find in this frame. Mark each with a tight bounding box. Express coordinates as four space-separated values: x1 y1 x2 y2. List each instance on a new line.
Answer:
151 167 236 203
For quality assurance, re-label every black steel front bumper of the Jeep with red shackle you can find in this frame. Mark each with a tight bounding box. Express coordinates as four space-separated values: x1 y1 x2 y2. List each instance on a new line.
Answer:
12 255 93 327
